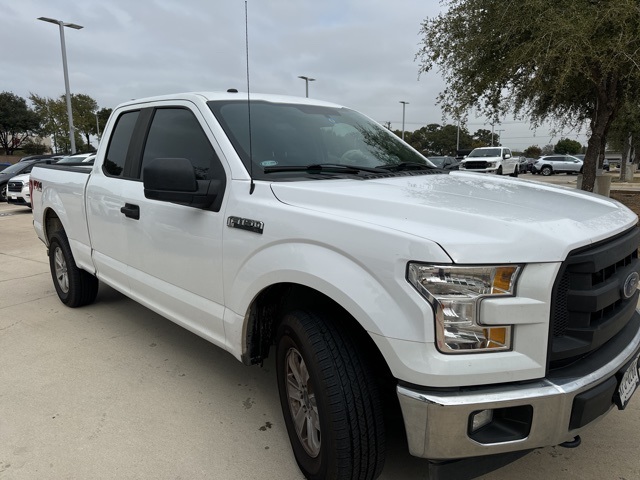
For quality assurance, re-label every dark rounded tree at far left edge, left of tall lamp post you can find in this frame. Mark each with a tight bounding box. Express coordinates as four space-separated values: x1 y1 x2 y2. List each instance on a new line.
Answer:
0 92 38 155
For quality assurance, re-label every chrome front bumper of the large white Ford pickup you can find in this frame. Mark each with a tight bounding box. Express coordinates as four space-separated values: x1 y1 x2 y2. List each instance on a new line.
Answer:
397 312 640 460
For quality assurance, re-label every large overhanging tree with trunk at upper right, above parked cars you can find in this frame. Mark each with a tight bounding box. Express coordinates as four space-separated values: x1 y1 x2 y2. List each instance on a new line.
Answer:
417 0 640 191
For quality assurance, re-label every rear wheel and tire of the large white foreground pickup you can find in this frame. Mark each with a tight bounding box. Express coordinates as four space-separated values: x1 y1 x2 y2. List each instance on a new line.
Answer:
49 231 98 308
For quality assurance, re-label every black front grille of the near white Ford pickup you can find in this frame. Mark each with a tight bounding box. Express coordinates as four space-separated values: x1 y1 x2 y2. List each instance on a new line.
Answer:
549 228 640 370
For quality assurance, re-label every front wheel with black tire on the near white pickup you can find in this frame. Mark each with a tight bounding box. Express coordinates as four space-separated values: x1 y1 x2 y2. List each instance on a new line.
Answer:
276 310 385 480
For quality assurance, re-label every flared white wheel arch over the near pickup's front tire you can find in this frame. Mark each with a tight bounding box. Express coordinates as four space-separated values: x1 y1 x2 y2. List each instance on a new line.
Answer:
226 242 440 343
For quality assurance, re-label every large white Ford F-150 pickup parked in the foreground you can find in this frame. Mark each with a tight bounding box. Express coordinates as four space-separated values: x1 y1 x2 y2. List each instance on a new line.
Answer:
31 92 640 479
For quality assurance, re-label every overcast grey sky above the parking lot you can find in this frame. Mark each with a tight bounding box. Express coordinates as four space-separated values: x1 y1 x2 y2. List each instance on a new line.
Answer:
0 0 586 150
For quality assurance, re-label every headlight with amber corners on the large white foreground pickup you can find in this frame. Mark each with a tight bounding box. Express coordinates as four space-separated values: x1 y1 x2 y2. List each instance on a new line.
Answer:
407 263 522 353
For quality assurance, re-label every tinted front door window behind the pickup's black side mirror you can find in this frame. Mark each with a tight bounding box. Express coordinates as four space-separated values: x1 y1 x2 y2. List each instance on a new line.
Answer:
140 108 224 180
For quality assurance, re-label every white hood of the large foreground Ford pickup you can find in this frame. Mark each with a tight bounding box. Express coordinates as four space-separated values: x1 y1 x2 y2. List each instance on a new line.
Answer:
271 172 638 263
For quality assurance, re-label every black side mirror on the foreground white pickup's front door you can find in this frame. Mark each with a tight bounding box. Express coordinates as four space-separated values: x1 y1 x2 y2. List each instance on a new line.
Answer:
142 158 224 209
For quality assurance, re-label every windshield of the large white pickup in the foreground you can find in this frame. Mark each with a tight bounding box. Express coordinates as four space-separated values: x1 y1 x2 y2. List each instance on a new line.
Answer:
209 100 431 180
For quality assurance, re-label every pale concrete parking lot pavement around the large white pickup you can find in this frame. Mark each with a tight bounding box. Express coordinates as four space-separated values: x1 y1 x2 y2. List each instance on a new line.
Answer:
0 203 640 480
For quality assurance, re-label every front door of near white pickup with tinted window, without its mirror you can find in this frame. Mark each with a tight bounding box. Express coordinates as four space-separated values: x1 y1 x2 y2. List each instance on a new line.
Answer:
121 102 226 345
